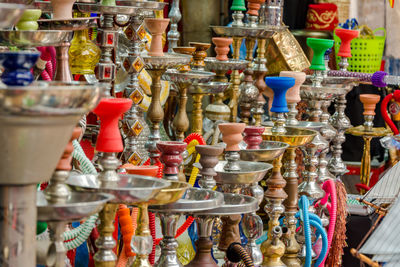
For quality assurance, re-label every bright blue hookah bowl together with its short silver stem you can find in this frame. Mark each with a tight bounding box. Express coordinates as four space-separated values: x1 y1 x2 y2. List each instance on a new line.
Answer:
265 77 295 134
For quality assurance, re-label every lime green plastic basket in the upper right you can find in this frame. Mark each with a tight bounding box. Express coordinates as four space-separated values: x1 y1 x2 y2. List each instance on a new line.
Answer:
333 28 386 73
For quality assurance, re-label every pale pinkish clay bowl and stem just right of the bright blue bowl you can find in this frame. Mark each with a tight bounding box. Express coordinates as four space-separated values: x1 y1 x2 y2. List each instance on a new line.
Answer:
279 71 306 126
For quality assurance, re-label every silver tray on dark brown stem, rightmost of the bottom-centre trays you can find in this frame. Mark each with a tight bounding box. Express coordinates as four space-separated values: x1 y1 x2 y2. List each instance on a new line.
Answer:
185 193 258 267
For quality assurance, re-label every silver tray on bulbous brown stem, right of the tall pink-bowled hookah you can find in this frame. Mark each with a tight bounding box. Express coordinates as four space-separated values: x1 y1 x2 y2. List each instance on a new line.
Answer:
162 70 215 141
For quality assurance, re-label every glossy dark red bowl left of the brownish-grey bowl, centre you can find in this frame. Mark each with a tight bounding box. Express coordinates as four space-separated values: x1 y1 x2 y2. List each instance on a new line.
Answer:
157 141 187 175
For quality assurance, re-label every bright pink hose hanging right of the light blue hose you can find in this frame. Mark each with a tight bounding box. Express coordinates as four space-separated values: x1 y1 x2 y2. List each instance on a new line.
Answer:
316 180 337 267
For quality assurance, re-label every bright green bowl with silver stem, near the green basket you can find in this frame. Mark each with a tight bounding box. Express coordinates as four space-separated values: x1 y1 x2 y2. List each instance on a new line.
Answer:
307 38 334 87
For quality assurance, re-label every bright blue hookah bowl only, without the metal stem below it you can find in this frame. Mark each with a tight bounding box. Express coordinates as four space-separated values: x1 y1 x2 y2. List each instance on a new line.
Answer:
265 77 296 113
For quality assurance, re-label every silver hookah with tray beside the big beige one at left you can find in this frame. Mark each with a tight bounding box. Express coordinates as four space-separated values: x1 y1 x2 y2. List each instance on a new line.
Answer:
36 128 113 267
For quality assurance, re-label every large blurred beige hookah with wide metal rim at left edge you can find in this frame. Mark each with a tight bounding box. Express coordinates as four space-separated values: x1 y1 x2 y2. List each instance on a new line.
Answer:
0 82 102 267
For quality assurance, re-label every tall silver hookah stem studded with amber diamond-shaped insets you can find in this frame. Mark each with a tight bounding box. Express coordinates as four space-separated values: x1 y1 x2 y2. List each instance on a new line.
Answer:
119 0 166 165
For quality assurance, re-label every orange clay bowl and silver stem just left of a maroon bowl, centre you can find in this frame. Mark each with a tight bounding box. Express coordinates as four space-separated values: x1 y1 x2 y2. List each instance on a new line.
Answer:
218 123 246 171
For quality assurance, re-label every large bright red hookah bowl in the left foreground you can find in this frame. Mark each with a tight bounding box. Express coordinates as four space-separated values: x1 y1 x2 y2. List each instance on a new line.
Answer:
93 98 132 153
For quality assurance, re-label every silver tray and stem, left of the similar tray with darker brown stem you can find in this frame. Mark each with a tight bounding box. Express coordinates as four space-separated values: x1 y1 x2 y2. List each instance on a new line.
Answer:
150 188 224 267
